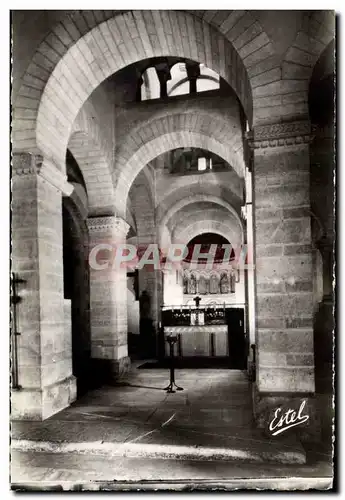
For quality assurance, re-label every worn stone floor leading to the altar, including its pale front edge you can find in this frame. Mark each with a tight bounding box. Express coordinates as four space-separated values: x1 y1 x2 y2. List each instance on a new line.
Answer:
12 369 332 481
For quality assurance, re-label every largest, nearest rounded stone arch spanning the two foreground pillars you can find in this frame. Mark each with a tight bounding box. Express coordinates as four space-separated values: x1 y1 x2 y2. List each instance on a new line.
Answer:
13 11 252 168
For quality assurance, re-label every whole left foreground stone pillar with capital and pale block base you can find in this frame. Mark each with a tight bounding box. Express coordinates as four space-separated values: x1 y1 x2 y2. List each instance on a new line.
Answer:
11 153 76 420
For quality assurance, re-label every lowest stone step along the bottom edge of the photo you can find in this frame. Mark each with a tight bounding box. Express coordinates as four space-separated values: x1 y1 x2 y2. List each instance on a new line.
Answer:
11 451 333 493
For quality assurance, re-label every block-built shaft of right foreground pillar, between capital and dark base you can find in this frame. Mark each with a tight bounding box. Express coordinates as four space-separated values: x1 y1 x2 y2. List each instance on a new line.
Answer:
254 146 314 392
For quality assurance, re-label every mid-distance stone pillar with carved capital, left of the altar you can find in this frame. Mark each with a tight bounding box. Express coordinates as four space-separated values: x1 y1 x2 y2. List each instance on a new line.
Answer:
87 216 130 382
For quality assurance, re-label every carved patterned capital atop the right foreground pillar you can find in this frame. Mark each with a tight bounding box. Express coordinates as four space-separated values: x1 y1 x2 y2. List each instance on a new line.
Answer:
246 120 312 149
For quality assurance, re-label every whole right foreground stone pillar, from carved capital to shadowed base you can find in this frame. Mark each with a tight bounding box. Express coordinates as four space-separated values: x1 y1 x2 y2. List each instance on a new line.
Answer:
247 121 316 440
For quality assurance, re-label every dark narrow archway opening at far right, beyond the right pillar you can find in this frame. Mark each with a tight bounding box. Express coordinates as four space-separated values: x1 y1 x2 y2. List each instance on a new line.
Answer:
309 40 336 410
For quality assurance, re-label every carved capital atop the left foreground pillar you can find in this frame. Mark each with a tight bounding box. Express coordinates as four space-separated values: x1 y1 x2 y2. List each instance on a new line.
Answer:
12 152 73 196
